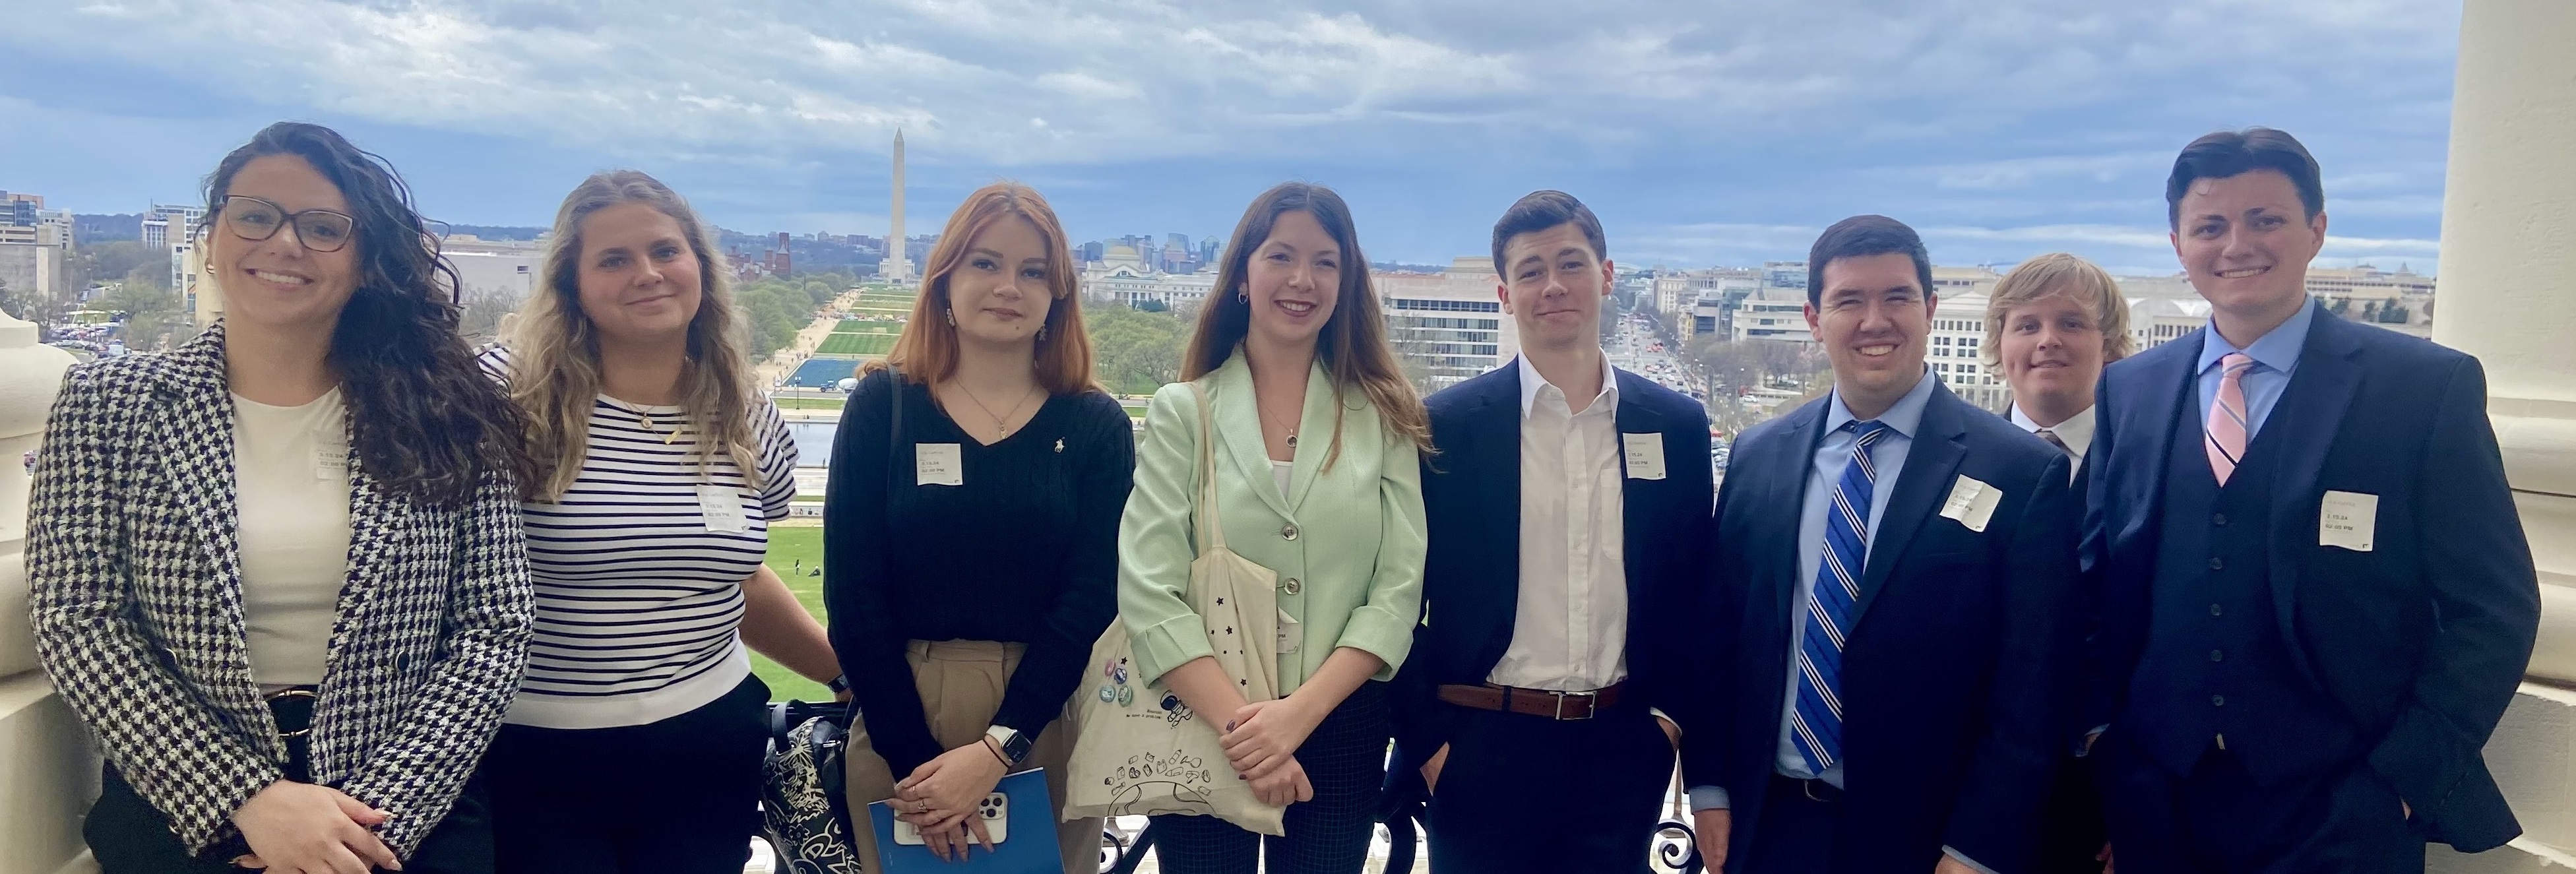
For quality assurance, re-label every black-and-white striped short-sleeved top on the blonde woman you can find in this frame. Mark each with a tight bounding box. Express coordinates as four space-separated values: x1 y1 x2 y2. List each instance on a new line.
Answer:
482 346 796 730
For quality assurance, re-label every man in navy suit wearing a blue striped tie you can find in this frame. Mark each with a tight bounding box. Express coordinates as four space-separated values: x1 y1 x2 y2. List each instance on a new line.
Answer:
1682 216 2079 874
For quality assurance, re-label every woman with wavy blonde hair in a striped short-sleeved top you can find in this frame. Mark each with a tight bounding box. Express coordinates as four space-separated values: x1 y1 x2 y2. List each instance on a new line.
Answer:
482 170 840 874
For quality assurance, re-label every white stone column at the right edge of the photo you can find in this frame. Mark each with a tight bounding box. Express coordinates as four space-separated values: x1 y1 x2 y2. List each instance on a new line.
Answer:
2432 0 2576 871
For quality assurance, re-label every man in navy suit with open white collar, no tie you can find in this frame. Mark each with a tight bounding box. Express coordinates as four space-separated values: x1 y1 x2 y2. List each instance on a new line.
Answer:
1394 191 1711 874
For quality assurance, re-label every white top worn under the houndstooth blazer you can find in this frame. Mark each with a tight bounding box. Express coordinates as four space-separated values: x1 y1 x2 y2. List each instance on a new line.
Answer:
232 389 350 691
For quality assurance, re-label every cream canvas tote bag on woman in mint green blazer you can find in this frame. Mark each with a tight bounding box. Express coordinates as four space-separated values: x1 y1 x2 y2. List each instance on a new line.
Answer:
1064 381 1286 835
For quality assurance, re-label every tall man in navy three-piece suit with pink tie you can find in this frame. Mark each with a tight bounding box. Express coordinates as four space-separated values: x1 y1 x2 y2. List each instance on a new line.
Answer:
2084 129 2540 874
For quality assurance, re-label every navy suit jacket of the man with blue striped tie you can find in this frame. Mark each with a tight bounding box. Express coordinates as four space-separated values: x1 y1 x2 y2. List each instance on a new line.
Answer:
1682 384 2079 874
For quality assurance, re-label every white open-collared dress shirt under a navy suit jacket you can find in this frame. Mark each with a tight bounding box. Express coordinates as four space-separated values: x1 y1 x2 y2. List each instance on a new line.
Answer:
1486 358 1628 691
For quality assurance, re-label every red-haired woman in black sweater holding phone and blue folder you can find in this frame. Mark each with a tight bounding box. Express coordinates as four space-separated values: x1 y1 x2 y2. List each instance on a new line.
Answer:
825 183 1136 874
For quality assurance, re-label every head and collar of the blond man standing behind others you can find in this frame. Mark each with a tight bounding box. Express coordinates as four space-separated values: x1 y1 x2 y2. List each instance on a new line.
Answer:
1984 253 2135 472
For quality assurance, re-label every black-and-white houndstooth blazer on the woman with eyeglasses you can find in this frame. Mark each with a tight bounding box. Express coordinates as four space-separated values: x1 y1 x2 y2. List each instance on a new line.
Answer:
26 325 533 856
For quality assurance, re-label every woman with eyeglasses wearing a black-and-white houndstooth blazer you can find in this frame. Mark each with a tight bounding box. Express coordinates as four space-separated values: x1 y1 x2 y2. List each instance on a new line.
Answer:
28 124 530 874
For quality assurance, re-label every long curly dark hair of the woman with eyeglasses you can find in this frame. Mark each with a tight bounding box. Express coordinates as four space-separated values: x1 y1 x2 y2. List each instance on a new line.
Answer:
199 121 530 505
